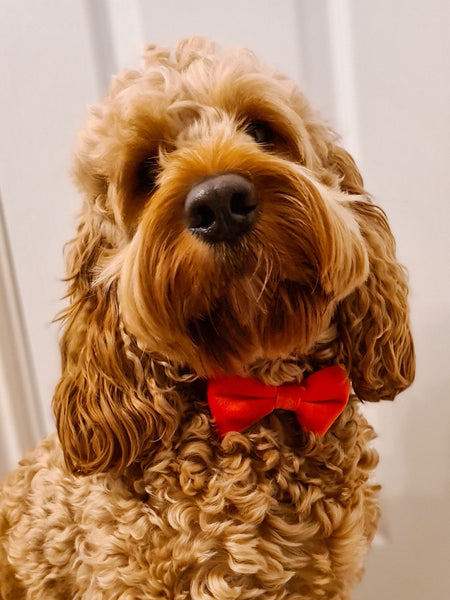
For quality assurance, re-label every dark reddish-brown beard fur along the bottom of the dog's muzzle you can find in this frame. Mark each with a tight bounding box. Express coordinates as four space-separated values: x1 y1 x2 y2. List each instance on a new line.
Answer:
122 270 334 377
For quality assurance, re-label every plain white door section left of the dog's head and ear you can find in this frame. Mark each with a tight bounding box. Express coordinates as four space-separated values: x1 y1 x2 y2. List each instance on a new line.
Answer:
0 0 99 460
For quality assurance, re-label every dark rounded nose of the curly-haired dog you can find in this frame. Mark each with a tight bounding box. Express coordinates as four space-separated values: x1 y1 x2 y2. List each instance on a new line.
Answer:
184 173 257 243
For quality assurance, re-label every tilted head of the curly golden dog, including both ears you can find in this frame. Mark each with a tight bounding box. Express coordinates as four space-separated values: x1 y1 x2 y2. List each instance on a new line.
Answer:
54 38 414 472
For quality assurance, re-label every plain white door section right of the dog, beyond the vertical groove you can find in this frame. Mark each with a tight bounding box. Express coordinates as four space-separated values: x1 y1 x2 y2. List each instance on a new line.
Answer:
351 0 450 600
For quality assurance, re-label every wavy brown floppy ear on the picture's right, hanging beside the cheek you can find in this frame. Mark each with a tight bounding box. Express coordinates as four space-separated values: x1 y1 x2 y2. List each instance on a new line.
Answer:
324 144 415 401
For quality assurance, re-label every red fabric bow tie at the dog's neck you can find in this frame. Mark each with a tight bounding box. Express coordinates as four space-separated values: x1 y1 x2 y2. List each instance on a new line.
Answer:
208 366 350 437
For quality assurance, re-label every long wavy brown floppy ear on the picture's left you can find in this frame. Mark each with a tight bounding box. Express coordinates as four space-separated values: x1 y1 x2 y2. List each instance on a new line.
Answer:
53 198 181 474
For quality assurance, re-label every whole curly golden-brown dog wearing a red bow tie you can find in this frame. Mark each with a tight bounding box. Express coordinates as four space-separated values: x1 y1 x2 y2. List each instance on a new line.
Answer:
0 38 414 600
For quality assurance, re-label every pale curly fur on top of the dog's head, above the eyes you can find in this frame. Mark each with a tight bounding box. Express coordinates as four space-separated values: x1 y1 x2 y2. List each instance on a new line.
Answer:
74 40 320 195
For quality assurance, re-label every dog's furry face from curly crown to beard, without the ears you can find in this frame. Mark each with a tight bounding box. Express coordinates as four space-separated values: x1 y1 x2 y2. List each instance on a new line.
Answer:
74 38 368 375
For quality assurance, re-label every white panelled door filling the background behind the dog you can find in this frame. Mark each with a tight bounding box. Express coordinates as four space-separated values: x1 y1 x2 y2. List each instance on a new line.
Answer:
0 0 450 600
